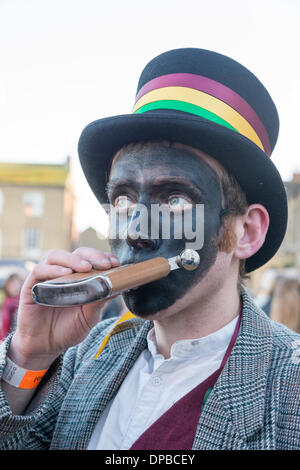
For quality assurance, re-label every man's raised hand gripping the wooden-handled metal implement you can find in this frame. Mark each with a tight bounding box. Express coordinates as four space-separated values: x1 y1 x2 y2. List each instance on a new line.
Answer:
8 247 120 370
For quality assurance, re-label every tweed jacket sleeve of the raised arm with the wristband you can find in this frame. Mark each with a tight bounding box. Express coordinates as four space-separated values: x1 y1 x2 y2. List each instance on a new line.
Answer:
0 319 113 450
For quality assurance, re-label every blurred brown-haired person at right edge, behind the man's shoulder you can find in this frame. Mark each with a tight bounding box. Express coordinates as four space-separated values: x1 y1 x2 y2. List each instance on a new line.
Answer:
270 278 300 333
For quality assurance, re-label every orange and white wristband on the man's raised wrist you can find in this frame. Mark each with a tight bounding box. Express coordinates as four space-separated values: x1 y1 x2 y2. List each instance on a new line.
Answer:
2 357 48 389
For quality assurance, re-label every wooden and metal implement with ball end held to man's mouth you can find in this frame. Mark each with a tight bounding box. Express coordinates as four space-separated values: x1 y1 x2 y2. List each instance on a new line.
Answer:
32 249 200 307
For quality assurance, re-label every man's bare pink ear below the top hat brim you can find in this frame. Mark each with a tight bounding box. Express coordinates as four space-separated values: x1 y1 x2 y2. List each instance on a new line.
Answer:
234 204 270 259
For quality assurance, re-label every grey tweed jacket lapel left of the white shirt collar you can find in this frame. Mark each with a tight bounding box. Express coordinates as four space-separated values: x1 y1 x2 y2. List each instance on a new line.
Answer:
51 319 152 449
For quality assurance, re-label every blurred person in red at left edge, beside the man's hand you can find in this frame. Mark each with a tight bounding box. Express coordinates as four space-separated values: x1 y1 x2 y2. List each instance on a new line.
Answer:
0 273 24 341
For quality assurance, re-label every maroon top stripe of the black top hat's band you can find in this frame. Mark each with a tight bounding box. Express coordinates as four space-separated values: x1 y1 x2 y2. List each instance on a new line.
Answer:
136 73 271 156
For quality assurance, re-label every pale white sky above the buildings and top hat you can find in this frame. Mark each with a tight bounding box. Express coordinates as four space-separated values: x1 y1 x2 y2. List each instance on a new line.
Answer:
0 0 300 235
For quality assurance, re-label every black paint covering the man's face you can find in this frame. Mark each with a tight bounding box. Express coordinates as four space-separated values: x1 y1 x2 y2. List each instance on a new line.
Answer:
108 144 222 318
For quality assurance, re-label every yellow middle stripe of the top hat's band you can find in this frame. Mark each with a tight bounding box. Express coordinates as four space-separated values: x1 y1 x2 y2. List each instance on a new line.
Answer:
132 86 264 151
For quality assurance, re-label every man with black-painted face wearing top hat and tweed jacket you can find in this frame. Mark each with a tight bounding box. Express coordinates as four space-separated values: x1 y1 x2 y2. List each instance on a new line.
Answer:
0 48 300 450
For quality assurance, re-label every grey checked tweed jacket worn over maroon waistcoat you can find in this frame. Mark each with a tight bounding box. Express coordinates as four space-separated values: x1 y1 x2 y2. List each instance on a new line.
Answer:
0 292 300 450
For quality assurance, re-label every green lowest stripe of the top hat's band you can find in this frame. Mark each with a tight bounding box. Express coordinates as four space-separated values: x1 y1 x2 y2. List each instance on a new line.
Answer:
134 100 237 132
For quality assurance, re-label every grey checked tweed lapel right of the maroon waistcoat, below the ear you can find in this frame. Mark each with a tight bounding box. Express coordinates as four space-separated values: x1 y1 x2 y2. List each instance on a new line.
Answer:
193 292 271 449
